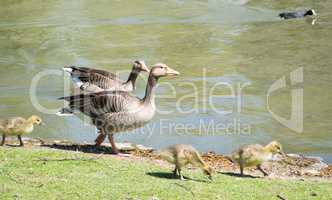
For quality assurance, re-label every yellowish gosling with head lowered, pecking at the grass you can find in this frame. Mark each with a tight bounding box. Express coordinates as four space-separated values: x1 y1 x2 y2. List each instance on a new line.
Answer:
158 144 213 180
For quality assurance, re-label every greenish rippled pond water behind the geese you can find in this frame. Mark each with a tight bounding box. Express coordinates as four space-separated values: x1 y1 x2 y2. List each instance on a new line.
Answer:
0 0 332 161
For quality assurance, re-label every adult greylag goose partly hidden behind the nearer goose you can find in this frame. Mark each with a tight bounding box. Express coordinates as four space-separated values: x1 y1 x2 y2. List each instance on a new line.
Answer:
63 61 149 92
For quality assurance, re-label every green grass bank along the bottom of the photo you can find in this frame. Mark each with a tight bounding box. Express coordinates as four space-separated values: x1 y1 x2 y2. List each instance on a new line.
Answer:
0 147 332 200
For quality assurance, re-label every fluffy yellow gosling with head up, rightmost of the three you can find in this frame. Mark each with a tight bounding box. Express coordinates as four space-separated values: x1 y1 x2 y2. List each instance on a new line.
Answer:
230 141 285 176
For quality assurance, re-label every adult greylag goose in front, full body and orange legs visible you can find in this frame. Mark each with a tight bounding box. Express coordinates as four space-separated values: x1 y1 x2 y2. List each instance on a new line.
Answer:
60 63 179 154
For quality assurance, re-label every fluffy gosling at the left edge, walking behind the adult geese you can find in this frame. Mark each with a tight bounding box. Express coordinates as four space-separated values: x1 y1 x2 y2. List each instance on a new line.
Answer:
0 115 42 146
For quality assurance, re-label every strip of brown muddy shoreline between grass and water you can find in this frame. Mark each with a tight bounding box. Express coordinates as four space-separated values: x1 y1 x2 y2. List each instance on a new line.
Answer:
2 138 332 181
